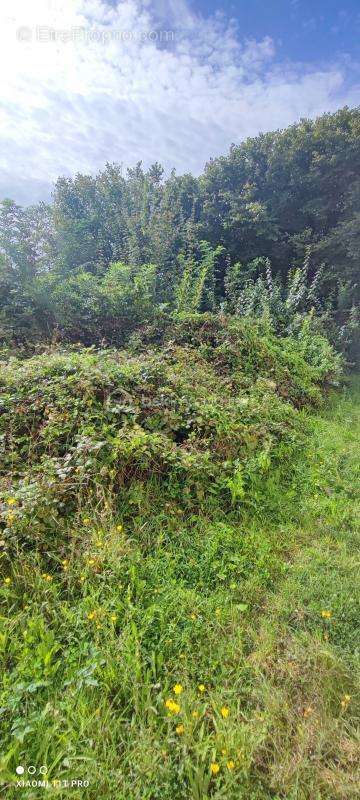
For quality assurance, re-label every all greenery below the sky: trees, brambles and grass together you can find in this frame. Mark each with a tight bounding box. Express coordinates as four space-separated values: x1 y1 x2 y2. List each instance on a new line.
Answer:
0 109 360 800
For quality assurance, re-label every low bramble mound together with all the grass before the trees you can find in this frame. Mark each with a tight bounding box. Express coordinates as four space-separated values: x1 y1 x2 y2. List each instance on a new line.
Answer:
0 315 359 800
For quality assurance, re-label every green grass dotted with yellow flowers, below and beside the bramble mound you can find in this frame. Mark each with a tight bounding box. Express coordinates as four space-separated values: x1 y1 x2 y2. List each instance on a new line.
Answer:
0 336 360 800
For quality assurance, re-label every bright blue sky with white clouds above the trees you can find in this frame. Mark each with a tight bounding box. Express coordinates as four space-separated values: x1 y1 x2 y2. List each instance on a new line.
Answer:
0 0 360 205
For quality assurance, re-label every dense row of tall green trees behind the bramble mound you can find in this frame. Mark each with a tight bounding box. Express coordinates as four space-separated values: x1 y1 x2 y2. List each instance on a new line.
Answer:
0 108 360 358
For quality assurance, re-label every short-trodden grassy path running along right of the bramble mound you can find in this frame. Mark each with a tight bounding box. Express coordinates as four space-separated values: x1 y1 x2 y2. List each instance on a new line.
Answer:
246 378 360 800
